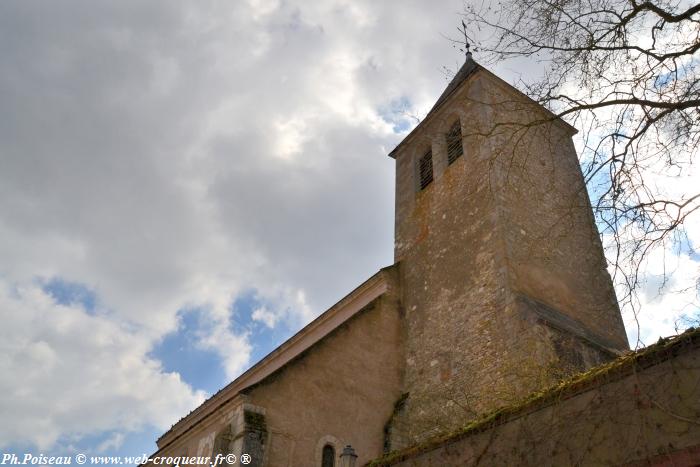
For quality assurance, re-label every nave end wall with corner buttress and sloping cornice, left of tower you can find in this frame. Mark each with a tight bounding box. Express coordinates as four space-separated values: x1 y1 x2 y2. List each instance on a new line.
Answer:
153 268 405 466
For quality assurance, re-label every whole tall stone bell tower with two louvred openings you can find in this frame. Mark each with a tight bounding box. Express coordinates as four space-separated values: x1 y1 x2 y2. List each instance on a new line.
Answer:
390 54 629 449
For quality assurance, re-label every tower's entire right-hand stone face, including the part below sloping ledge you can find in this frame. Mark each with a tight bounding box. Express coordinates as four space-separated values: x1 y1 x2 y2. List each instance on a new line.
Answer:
484 74 629 397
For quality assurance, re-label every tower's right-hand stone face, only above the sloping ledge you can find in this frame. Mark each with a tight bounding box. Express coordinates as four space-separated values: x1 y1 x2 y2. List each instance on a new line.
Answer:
487 74 629 351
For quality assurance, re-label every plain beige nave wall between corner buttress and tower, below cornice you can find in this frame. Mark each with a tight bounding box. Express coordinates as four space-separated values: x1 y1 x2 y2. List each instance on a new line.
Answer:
245 270 404 467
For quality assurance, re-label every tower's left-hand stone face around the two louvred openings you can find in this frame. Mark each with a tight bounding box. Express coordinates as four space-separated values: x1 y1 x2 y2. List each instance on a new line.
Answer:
391 73 512 449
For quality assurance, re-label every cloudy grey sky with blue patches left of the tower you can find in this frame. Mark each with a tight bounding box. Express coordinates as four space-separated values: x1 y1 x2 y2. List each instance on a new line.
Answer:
0 0 697 455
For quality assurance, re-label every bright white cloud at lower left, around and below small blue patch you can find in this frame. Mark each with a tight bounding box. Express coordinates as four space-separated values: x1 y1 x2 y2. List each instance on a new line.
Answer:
0 281 204 449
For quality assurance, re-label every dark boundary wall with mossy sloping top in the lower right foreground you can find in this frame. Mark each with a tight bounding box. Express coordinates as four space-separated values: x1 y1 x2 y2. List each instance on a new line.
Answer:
367 329 700 467
